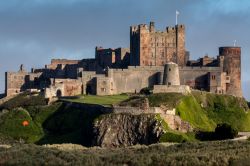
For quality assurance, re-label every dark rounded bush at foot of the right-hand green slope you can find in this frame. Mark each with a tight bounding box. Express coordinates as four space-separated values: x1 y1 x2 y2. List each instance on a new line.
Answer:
214 123 238 140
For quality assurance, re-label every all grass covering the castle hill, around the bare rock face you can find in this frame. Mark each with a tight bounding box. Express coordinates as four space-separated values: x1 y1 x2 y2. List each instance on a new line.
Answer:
0 92 250 146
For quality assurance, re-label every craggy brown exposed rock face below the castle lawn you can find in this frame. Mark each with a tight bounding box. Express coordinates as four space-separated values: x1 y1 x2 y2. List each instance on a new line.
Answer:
93 114 164 147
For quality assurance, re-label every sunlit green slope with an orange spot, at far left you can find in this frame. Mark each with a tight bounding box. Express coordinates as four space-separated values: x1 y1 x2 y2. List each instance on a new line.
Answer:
0 104 60 143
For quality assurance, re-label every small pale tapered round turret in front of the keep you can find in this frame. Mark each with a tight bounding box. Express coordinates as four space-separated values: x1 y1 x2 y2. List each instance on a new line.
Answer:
163 62 180 85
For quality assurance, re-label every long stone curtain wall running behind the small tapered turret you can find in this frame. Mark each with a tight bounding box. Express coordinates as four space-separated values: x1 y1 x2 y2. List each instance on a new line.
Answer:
92 66 230 95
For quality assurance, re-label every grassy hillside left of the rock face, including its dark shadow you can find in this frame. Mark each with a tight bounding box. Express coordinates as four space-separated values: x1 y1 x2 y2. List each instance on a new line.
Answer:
0 94 104 146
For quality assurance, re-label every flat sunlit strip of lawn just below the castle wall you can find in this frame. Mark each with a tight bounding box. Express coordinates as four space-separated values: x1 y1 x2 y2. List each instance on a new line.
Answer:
63 94 129 106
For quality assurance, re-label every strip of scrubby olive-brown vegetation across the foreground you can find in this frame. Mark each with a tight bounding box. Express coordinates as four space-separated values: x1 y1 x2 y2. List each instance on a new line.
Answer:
0 141 250 166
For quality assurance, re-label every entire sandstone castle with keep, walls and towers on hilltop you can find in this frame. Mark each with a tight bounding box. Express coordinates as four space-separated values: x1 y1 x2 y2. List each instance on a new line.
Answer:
5 22 242 98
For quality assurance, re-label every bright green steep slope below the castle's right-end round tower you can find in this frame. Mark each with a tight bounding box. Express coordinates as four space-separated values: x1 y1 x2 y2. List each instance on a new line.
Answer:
177 92 250 131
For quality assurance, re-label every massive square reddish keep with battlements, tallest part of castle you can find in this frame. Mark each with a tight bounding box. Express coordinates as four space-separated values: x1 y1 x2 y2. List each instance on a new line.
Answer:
130 22 187 66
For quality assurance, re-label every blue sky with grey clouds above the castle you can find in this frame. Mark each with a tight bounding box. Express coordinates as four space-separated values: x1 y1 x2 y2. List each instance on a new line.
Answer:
0 0 250 100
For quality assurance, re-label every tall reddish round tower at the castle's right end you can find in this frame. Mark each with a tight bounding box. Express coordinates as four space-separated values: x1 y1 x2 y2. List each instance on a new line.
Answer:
219 47 242 97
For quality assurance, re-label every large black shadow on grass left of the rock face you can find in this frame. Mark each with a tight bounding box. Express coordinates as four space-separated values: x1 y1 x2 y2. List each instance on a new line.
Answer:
36 103 107 147
